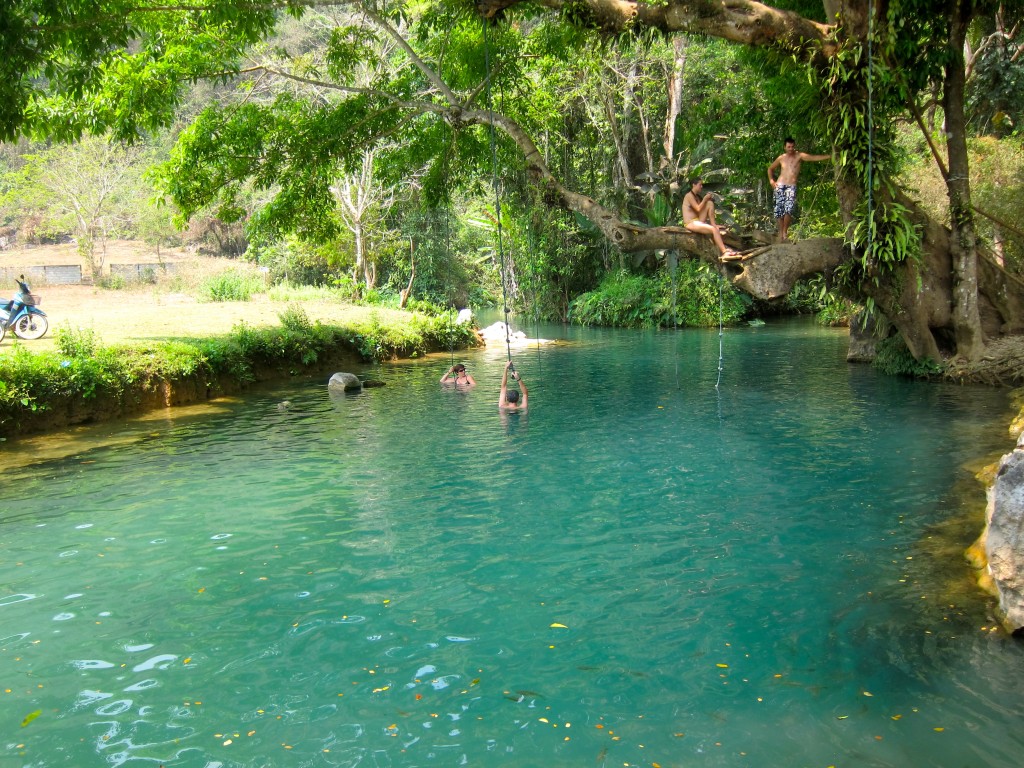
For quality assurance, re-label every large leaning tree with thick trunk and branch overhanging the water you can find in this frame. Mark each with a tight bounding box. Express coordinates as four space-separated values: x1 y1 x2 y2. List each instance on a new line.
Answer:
0 0 1022 360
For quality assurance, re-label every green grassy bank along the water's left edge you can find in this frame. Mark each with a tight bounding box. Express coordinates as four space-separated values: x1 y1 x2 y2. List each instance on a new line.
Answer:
0 305 477 437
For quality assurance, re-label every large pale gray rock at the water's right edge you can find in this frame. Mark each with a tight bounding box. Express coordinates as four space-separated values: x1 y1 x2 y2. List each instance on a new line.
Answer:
985 437 1024 632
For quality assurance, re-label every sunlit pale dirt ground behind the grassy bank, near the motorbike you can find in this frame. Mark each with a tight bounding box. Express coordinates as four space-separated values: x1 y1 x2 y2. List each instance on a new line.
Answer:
0 243 407 353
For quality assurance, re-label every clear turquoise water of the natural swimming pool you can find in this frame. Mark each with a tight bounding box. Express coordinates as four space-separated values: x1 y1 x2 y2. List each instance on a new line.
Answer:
0 323 1024 768
